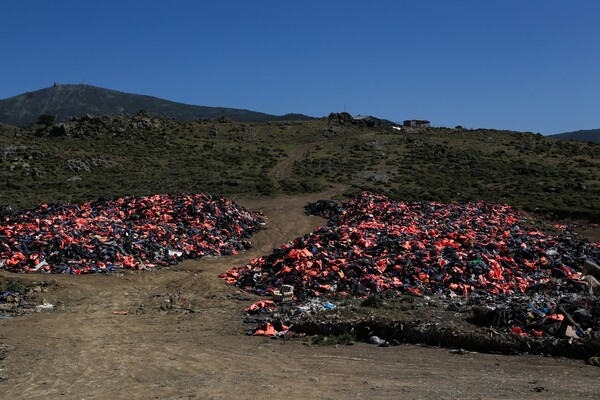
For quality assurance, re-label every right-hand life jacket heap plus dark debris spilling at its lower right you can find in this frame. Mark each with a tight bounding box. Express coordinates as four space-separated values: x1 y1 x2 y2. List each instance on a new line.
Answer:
221 193 600 337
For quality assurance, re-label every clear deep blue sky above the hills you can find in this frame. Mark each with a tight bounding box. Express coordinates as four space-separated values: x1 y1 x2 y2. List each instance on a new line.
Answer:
0 0 600 134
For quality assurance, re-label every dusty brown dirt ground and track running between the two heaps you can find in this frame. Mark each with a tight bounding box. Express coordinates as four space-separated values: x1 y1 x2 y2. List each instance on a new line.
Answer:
0 194 600 399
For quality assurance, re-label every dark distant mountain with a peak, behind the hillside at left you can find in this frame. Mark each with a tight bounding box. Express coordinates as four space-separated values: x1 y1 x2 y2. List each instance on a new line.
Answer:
0 84 314 125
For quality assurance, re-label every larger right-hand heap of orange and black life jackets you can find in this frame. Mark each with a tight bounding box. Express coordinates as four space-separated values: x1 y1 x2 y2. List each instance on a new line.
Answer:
221 193 600 299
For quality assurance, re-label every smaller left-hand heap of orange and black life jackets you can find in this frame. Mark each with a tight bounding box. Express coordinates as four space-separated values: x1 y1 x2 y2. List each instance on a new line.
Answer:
0 194 264 274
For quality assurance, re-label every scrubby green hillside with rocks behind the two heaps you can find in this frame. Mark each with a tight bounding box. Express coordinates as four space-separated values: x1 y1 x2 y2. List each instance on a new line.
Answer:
0 114 600 222
